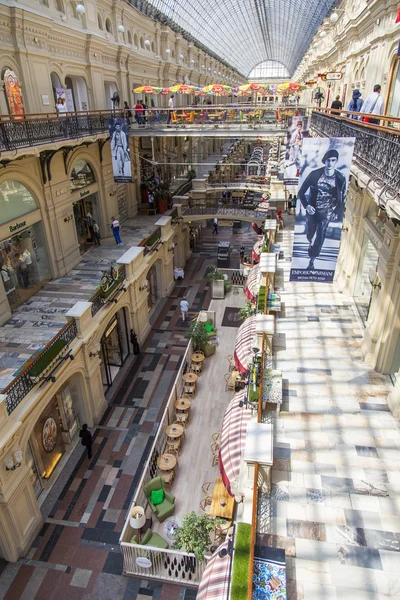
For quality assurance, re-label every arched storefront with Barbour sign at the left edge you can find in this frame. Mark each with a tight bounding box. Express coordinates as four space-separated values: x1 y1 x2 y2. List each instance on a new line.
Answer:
0 179 51 310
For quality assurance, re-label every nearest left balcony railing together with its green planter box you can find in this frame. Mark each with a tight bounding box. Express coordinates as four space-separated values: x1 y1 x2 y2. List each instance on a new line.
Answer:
2 319 77 415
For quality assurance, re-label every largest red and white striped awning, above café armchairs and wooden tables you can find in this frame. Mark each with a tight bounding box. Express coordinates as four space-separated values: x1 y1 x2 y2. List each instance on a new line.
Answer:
219 390 252 496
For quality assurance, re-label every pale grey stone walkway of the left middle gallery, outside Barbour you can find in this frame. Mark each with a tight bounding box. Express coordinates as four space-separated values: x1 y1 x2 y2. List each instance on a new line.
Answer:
0 215 160 390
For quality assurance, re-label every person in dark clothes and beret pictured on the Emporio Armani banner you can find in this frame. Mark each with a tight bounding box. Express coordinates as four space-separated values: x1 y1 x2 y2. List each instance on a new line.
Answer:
298 149 346 269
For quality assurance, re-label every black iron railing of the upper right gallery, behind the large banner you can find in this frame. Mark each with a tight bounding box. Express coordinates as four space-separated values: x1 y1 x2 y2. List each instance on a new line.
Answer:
311 112 400 196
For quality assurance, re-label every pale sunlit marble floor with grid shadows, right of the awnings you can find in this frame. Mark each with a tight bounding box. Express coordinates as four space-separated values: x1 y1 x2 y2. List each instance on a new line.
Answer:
259 217 400 600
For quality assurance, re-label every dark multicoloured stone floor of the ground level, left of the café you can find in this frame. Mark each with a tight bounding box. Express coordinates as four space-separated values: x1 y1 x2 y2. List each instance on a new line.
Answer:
0 224 257 600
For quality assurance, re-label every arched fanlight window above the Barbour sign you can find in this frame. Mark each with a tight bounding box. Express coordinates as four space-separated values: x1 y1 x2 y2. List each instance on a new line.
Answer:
0 179 38 225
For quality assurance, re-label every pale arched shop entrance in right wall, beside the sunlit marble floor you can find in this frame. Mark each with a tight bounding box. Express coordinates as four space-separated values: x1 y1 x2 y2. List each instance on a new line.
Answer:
354 234 379 326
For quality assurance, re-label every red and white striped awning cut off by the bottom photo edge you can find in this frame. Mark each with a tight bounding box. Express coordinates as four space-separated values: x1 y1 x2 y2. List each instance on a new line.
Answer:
196 540 231 600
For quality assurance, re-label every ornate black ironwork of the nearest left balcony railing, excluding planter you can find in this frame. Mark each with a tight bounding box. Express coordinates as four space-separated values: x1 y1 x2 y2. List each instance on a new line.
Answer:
2 319 77 415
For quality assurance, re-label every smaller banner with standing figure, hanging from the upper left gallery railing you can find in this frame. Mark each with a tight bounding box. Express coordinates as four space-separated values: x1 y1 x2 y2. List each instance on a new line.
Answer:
108 117 132 183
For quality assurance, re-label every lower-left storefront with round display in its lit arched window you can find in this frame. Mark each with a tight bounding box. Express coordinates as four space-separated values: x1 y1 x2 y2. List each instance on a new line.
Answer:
26 383 79 497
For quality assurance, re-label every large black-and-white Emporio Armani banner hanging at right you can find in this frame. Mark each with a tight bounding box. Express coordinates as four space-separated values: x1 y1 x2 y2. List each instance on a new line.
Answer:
290 138 355 283
